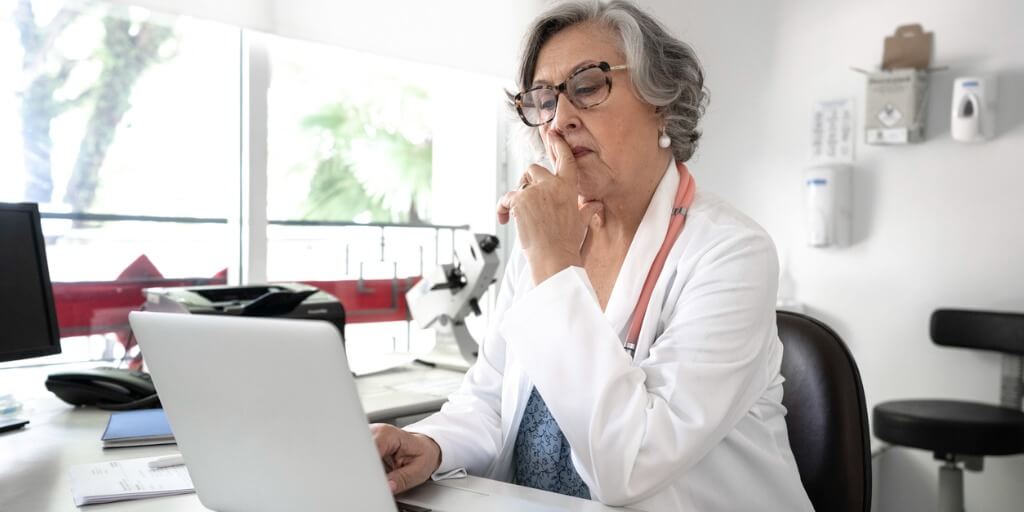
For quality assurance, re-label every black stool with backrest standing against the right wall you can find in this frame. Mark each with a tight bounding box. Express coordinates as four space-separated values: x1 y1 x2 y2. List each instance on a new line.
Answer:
872 309 1024 512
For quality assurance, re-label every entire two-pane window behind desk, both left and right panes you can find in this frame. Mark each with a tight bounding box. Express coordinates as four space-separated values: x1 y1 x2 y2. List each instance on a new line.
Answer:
0 0 505 368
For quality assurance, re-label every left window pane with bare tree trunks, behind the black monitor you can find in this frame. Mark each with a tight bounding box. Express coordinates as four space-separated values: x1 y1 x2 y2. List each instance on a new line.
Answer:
0 0 241 366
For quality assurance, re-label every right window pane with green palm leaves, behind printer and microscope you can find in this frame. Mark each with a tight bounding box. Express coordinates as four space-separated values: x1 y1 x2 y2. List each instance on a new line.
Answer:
265 37 502 358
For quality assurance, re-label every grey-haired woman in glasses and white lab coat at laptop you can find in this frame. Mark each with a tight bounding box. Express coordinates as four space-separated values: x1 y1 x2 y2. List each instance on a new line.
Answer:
373 1 811 511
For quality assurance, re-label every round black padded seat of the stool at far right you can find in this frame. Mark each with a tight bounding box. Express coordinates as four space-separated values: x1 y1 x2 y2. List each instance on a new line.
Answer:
872 400 1024 456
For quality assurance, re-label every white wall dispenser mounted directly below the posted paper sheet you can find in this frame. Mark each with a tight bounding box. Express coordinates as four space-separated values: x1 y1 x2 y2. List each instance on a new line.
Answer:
804 164 853 247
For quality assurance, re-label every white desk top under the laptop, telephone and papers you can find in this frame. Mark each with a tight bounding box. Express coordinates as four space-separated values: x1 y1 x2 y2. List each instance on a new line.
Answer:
0 369 623 512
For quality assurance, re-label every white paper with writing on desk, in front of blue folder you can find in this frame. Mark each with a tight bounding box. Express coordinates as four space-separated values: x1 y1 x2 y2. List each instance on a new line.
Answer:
71 457 195 507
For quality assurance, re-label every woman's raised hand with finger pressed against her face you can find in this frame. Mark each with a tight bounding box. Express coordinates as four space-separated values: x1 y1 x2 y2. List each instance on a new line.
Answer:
498 130 604 285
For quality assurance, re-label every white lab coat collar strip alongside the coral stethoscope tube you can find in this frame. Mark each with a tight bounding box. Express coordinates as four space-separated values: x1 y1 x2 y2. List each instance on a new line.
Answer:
604 159 679 343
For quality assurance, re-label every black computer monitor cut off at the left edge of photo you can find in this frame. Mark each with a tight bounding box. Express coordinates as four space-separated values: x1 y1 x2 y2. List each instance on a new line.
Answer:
0 203 60 361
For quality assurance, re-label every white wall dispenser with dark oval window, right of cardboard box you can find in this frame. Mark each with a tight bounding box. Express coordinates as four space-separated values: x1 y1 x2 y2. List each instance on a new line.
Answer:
949 77 995 142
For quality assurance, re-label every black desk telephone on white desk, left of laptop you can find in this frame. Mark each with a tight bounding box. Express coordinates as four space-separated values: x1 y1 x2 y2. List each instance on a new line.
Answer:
46 368 160 411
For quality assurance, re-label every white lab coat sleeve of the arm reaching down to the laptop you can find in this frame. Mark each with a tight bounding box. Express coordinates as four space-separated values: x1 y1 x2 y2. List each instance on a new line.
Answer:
404 256 515 479
